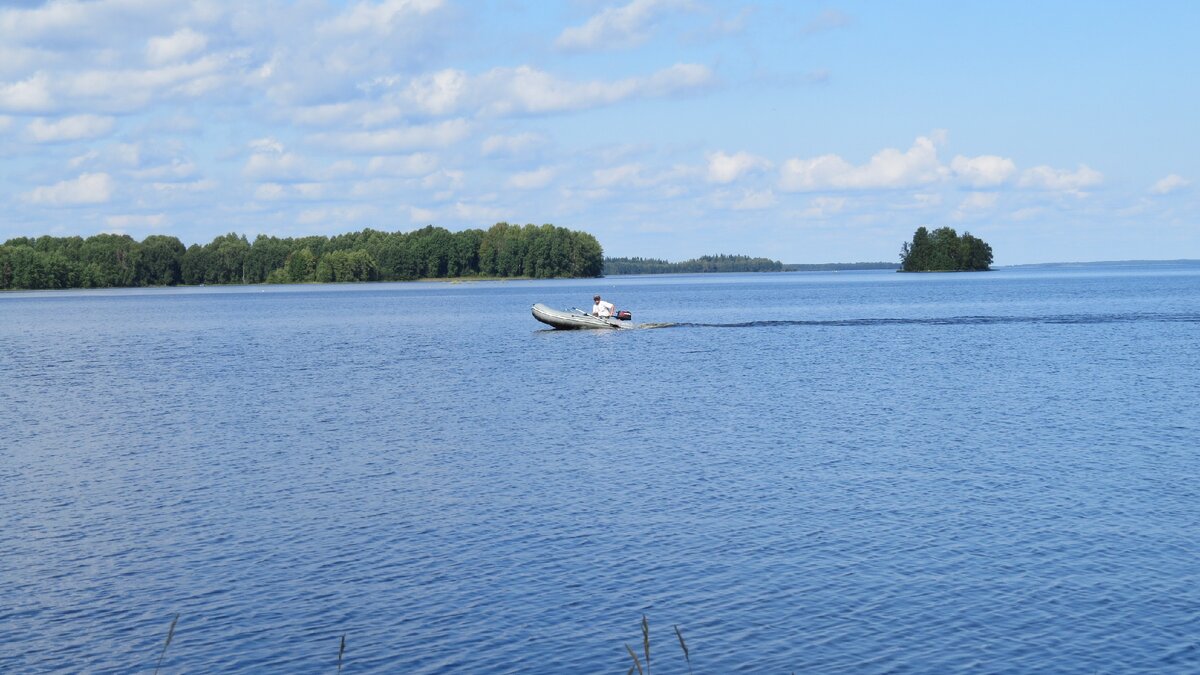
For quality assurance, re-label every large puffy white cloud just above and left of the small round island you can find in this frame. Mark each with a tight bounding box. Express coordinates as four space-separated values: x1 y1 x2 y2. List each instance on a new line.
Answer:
780 135 947 192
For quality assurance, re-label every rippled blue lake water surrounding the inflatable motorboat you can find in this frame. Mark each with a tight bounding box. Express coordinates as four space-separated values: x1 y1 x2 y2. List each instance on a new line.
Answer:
0 264 1200 674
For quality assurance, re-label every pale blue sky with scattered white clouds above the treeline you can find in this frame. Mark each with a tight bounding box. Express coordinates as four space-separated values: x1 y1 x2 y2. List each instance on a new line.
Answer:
0 0 1200 264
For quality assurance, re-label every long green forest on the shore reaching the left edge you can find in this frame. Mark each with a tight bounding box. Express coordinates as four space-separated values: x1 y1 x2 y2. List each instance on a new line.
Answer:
0 222 604 289
